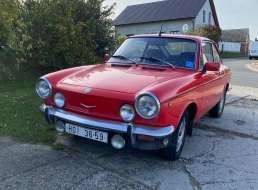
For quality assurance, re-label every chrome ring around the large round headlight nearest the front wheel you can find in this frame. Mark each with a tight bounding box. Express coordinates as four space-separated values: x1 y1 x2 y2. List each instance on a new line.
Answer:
135 92 160 119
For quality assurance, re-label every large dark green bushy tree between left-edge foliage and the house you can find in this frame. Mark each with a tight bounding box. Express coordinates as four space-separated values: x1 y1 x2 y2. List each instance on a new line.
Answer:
24 0 114 69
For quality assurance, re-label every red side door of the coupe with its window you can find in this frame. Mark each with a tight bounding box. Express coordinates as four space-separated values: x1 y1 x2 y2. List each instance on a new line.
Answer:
200 41 222 113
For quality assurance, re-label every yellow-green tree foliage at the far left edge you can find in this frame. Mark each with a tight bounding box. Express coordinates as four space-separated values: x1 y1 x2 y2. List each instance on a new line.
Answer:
0 0 27 79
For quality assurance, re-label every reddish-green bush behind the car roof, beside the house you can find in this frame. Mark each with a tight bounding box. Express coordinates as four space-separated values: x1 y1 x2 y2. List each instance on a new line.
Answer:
186 24 221 43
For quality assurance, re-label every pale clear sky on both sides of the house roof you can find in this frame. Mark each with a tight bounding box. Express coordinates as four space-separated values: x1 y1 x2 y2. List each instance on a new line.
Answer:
104 0 258 40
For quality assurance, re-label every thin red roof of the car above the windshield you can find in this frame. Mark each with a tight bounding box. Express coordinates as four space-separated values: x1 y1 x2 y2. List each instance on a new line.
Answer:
129 34 212 41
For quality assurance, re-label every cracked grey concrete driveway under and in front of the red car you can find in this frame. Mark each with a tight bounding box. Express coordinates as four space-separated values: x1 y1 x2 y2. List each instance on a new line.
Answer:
0 58 258 190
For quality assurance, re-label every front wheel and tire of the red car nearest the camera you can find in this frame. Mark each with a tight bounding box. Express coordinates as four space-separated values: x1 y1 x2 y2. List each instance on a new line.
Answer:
162 110 189 161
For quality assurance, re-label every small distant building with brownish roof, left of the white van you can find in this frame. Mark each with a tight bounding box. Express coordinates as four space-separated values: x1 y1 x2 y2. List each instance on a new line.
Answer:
219 28 250 54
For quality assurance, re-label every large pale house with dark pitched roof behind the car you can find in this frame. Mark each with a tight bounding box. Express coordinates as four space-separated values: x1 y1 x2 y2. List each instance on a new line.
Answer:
114 0 219 36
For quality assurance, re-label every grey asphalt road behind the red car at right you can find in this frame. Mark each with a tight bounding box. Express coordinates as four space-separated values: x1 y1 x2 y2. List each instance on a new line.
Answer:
223 57 258 88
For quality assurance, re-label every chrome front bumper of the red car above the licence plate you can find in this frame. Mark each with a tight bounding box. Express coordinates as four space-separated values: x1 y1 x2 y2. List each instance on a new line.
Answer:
39 104 175 149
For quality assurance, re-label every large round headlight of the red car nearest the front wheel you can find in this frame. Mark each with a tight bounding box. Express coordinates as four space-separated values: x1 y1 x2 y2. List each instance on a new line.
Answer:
135 92 160 119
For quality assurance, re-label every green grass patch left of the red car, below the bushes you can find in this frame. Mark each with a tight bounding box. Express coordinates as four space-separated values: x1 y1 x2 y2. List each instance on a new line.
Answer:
0 65 61 145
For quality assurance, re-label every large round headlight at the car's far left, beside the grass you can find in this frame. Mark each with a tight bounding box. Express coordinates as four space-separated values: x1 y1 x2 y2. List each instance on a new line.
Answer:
36 78 52 99
